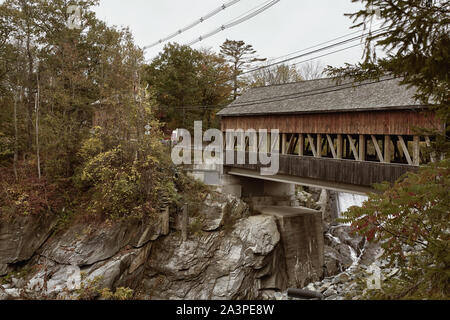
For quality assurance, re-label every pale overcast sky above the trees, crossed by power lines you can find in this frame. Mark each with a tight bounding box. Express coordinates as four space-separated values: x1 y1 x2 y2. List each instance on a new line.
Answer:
95 0 374 66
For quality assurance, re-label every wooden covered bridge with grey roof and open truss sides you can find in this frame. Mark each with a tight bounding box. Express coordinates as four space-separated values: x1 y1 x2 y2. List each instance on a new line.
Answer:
219 77 445 192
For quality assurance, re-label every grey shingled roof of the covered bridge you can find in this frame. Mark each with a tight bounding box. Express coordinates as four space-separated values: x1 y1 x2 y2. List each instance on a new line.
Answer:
219 78 422 117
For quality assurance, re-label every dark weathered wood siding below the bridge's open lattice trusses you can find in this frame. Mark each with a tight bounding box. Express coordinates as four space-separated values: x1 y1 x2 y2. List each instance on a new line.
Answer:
226 153 418 187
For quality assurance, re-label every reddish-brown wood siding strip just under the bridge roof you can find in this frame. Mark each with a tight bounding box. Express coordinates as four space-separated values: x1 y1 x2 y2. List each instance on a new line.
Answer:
222 110 444 135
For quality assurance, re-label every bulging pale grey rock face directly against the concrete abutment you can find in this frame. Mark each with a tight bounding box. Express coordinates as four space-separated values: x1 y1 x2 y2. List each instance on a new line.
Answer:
144 216 286 299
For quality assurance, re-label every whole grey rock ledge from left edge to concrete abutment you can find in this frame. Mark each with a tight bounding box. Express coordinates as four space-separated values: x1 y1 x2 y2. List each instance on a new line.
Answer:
0 194 287 299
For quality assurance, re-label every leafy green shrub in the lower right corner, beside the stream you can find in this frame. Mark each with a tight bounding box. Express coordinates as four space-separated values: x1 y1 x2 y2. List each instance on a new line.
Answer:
343 159 450 299
